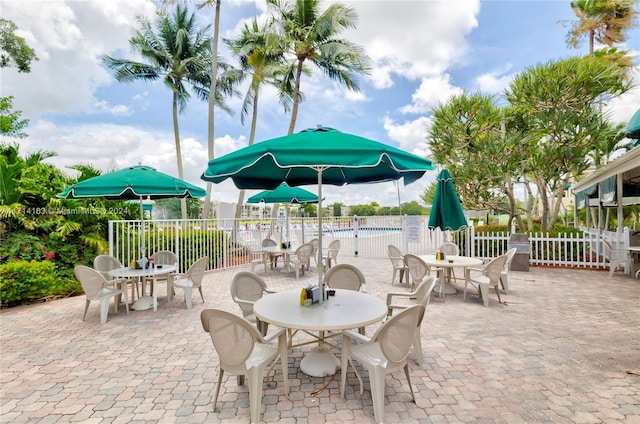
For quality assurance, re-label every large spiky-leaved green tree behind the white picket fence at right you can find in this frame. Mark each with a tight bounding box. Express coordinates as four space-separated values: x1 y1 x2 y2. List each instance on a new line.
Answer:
506 57 631 230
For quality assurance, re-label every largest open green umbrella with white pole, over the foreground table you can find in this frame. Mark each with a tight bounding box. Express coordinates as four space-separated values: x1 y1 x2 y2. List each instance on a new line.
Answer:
201 127 434 285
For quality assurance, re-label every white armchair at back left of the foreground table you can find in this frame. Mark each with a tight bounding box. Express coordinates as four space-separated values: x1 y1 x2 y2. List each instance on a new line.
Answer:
231 271 275 336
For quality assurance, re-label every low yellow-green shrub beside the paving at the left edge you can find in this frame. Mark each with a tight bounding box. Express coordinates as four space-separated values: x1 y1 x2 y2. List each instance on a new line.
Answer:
0 261 82 308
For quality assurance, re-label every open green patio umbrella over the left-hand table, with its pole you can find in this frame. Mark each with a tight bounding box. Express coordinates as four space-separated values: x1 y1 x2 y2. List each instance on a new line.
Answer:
56 165 207 255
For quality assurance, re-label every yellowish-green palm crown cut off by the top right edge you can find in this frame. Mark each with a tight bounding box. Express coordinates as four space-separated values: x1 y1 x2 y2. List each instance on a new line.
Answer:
567 0 637 56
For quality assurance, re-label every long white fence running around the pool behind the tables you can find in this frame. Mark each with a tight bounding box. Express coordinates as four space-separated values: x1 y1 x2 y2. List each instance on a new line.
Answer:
109 216 629 271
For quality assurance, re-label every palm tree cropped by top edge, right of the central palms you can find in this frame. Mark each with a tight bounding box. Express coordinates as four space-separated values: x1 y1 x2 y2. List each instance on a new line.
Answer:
267 0 369 134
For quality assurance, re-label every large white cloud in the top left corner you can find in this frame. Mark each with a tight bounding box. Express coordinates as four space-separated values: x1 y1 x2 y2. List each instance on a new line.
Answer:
2 0 155 118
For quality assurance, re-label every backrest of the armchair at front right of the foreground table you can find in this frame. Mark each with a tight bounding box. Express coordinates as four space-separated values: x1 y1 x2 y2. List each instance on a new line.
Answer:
373 305 425 368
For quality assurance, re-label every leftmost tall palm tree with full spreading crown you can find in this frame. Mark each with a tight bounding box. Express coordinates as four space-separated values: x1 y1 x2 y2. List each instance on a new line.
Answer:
103 4 221 219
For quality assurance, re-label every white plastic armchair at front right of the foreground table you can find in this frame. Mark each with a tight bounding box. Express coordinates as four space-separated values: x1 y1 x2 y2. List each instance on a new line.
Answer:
340 305 425 423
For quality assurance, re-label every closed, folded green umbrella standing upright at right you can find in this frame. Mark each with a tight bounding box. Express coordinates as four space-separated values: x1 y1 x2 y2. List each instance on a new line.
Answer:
429 169 467 231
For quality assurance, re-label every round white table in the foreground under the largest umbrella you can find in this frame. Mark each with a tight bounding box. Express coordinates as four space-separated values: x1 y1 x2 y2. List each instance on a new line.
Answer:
253 289 387 377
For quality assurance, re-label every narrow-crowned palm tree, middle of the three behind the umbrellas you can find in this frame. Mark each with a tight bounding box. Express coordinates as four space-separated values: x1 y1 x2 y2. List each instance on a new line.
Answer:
224 19 293 218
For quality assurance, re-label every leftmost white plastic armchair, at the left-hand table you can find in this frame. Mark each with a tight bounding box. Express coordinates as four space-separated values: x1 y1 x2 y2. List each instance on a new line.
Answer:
73 265 129 324
